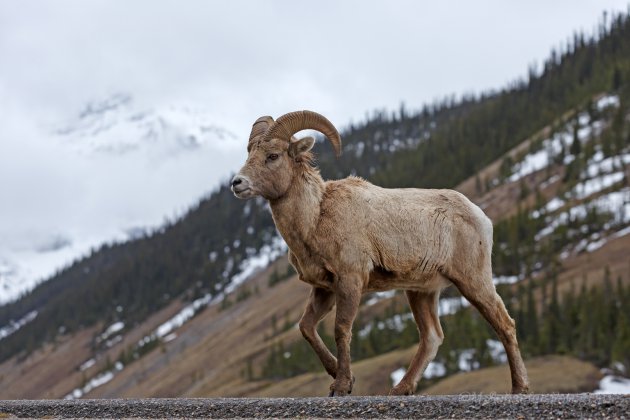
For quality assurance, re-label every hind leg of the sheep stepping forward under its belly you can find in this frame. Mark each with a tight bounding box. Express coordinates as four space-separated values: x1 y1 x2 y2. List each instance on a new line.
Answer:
389 290 444 395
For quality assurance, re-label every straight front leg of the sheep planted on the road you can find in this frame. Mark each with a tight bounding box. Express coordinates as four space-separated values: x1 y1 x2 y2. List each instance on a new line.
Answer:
330 276 363 397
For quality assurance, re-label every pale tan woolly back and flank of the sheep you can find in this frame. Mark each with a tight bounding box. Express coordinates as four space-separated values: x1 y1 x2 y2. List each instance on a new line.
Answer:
322 178 492 275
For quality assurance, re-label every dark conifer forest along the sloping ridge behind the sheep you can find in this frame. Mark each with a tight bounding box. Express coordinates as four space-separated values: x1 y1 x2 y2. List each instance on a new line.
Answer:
0 9 630 362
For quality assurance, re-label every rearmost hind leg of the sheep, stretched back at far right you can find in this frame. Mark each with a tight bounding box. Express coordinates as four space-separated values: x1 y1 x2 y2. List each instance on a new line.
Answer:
452 274 529 394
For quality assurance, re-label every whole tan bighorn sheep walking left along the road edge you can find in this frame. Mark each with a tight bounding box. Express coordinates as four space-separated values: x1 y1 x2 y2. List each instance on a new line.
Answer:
232 111 528 396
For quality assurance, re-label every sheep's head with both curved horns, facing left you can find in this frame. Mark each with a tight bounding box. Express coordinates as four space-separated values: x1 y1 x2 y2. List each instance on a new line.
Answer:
232 111 341 200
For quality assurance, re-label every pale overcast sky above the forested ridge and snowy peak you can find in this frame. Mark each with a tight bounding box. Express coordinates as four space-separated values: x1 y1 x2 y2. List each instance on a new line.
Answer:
0 0 628 296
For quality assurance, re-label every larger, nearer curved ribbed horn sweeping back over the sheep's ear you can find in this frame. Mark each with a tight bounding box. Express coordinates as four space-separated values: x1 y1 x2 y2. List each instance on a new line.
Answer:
265 111 341 156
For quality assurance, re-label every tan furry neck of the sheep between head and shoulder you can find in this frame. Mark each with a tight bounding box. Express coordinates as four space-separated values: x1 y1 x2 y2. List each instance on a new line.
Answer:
269 168 324 254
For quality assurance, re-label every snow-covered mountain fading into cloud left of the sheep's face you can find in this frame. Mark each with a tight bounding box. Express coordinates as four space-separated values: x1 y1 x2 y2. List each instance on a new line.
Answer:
0 94 244 304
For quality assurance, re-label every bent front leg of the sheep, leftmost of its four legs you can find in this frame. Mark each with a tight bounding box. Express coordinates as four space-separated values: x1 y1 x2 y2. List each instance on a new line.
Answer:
300 287 337 378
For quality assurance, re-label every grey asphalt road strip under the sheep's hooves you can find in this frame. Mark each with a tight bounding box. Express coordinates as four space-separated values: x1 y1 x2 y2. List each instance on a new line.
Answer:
0 394 630 419
